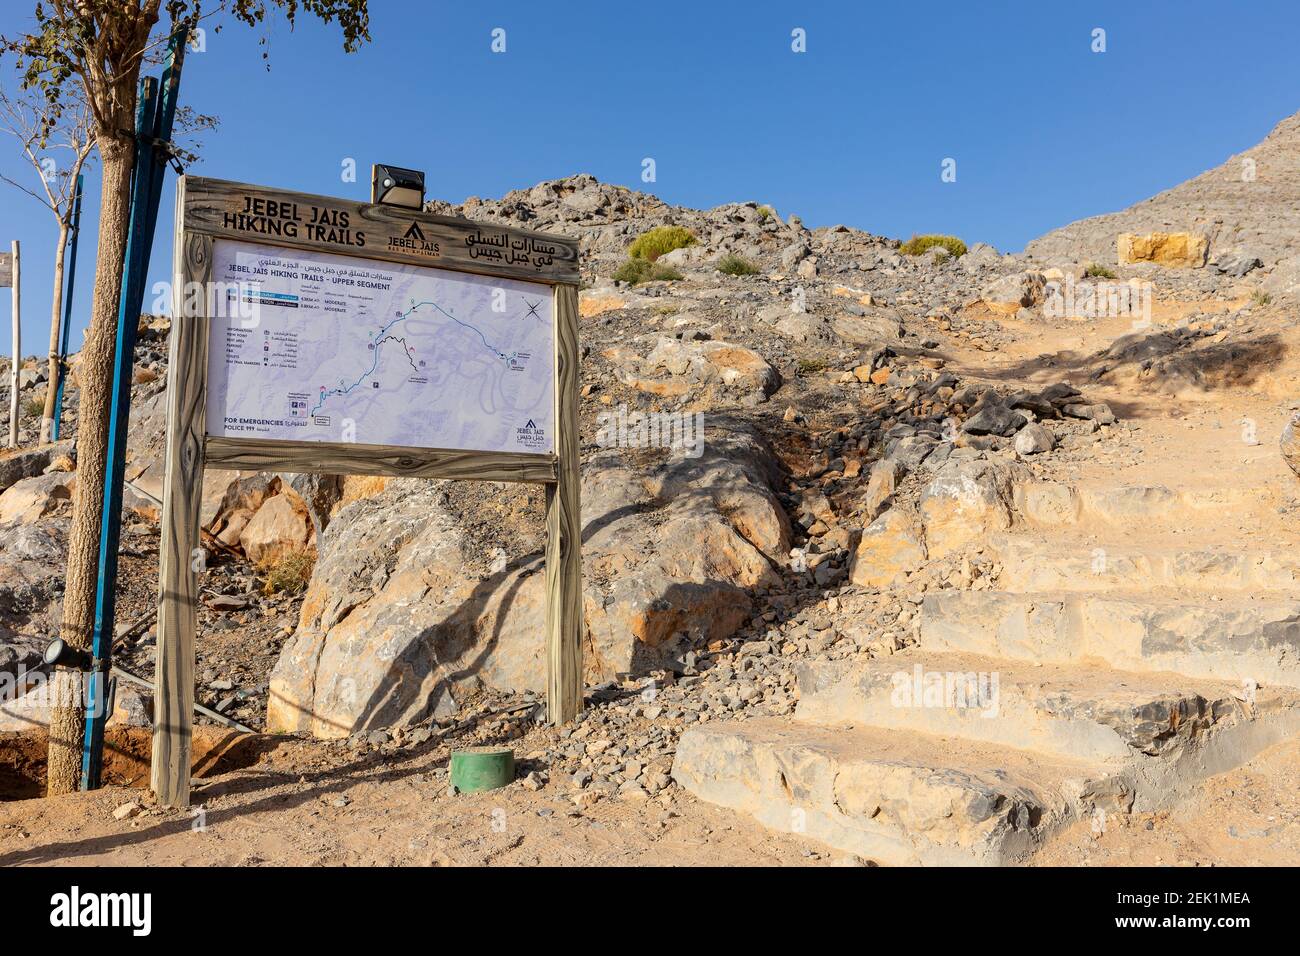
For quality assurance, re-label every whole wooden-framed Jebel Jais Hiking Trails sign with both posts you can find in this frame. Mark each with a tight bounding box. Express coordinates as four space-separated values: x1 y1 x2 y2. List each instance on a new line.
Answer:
152 177 582 806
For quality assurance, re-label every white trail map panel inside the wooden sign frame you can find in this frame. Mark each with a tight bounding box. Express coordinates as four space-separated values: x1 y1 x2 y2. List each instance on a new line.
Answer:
207 239 555 454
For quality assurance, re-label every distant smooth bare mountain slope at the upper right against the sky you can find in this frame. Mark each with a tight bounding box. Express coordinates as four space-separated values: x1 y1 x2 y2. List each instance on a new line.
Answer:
1024 113 1300 282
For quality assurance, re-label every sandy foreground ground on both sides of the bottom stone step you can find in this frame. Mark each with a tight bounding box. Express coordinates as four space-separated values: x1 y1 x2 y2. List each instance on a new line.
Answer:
0 717 1300 866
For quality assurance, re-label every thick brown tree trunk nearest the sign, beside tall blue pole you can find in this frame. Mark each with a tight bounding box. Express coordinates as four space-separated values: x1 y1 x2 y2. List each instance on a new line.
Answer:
47 135 134 795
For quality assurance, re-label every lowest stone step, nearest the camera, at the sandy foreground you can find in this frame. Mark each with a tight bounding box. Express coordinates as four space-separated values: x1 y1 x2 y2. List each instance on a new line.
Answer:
672 719 1086 866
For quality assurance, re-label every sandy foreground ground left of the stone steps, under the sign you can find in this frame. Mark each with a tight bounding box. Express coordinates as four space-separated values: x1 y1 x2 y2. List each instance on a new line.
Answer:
0 731 826 866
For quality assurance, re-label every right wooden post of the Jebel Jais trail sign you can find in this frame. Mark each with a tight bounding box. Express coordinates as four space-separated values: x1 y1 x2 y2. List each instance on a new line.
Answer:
546 284 584 723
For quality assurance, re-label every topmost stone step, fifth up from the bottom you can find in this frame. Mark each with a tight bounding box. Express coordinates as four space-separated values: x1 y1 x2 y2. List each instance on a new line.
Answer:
1013 481 1261 528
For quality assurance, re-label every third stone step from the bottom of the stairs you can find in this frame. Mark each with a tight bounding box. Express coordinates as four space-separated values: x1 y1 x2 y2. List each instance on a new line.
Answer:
920 591 1300 687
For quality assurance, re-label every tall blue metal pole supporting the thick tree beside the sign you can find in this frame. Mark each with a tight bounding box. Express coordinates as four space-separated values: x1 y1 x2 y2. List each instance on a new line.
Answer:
81 27 187 790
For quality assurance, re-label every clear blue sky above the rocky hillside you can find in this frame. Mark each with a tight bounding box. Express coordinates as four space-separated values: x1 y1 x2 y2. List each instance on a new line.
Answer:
0 0 1300 354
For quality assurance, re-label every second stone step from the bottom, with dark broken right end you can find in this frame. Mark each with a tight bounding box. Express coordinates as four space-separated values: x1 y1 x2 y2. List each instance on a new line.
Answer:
796 650 1300 809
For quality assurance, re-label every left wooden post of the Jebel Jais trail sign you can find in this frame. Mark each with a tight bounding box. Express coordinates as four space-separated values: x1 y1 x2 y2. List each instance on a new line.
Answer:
151 208 212 806
